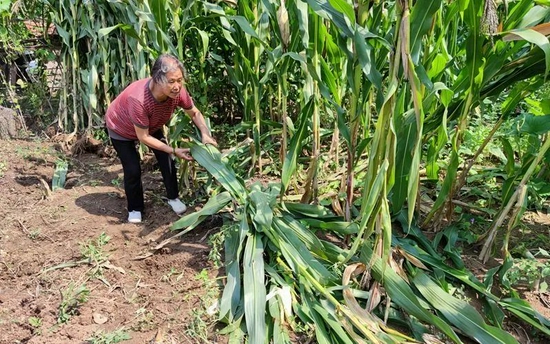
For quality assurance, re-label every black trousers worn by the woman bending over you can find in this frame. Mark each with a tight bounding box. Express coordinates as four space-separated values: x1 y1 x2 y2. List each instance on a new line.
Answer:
111 130 179 212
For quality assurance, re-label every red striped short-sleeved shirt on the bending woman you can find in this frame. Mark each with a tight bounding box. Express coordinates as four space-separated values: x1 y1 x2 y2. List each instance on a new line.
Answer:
105 78 194 140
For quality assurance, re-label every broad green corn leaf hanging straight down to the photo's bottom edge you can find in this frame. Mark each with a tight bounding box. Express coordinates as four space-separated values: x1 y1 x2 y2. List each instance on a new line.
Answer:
243 234 267 343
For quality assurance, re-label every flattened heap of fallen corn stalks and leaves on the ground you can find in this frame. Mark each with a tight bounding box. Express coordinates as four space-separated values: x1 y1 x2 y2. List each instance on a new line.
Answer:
173 144 550 343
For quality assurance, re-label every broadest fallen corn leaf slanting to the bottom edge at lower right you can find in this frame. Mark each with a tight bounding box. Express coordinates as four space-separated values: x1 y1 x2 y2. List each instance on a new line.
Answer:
413 271 518 343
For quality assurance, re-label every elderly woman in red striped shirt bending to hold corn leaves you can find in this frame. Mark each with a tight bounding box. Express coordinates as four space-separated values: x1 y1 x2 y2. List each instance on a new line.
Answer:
105 54 217 223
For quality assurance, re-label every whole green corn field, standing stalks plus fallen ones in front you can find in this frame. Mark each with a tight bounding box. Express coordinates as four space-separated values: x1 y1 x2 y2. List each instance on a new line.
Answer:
3 0 550 343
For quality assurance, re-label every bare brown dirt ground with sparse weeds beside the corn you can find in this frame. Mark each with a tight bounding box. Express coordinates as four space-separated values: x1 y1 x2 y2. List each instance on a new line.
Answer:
0 141 223 344
